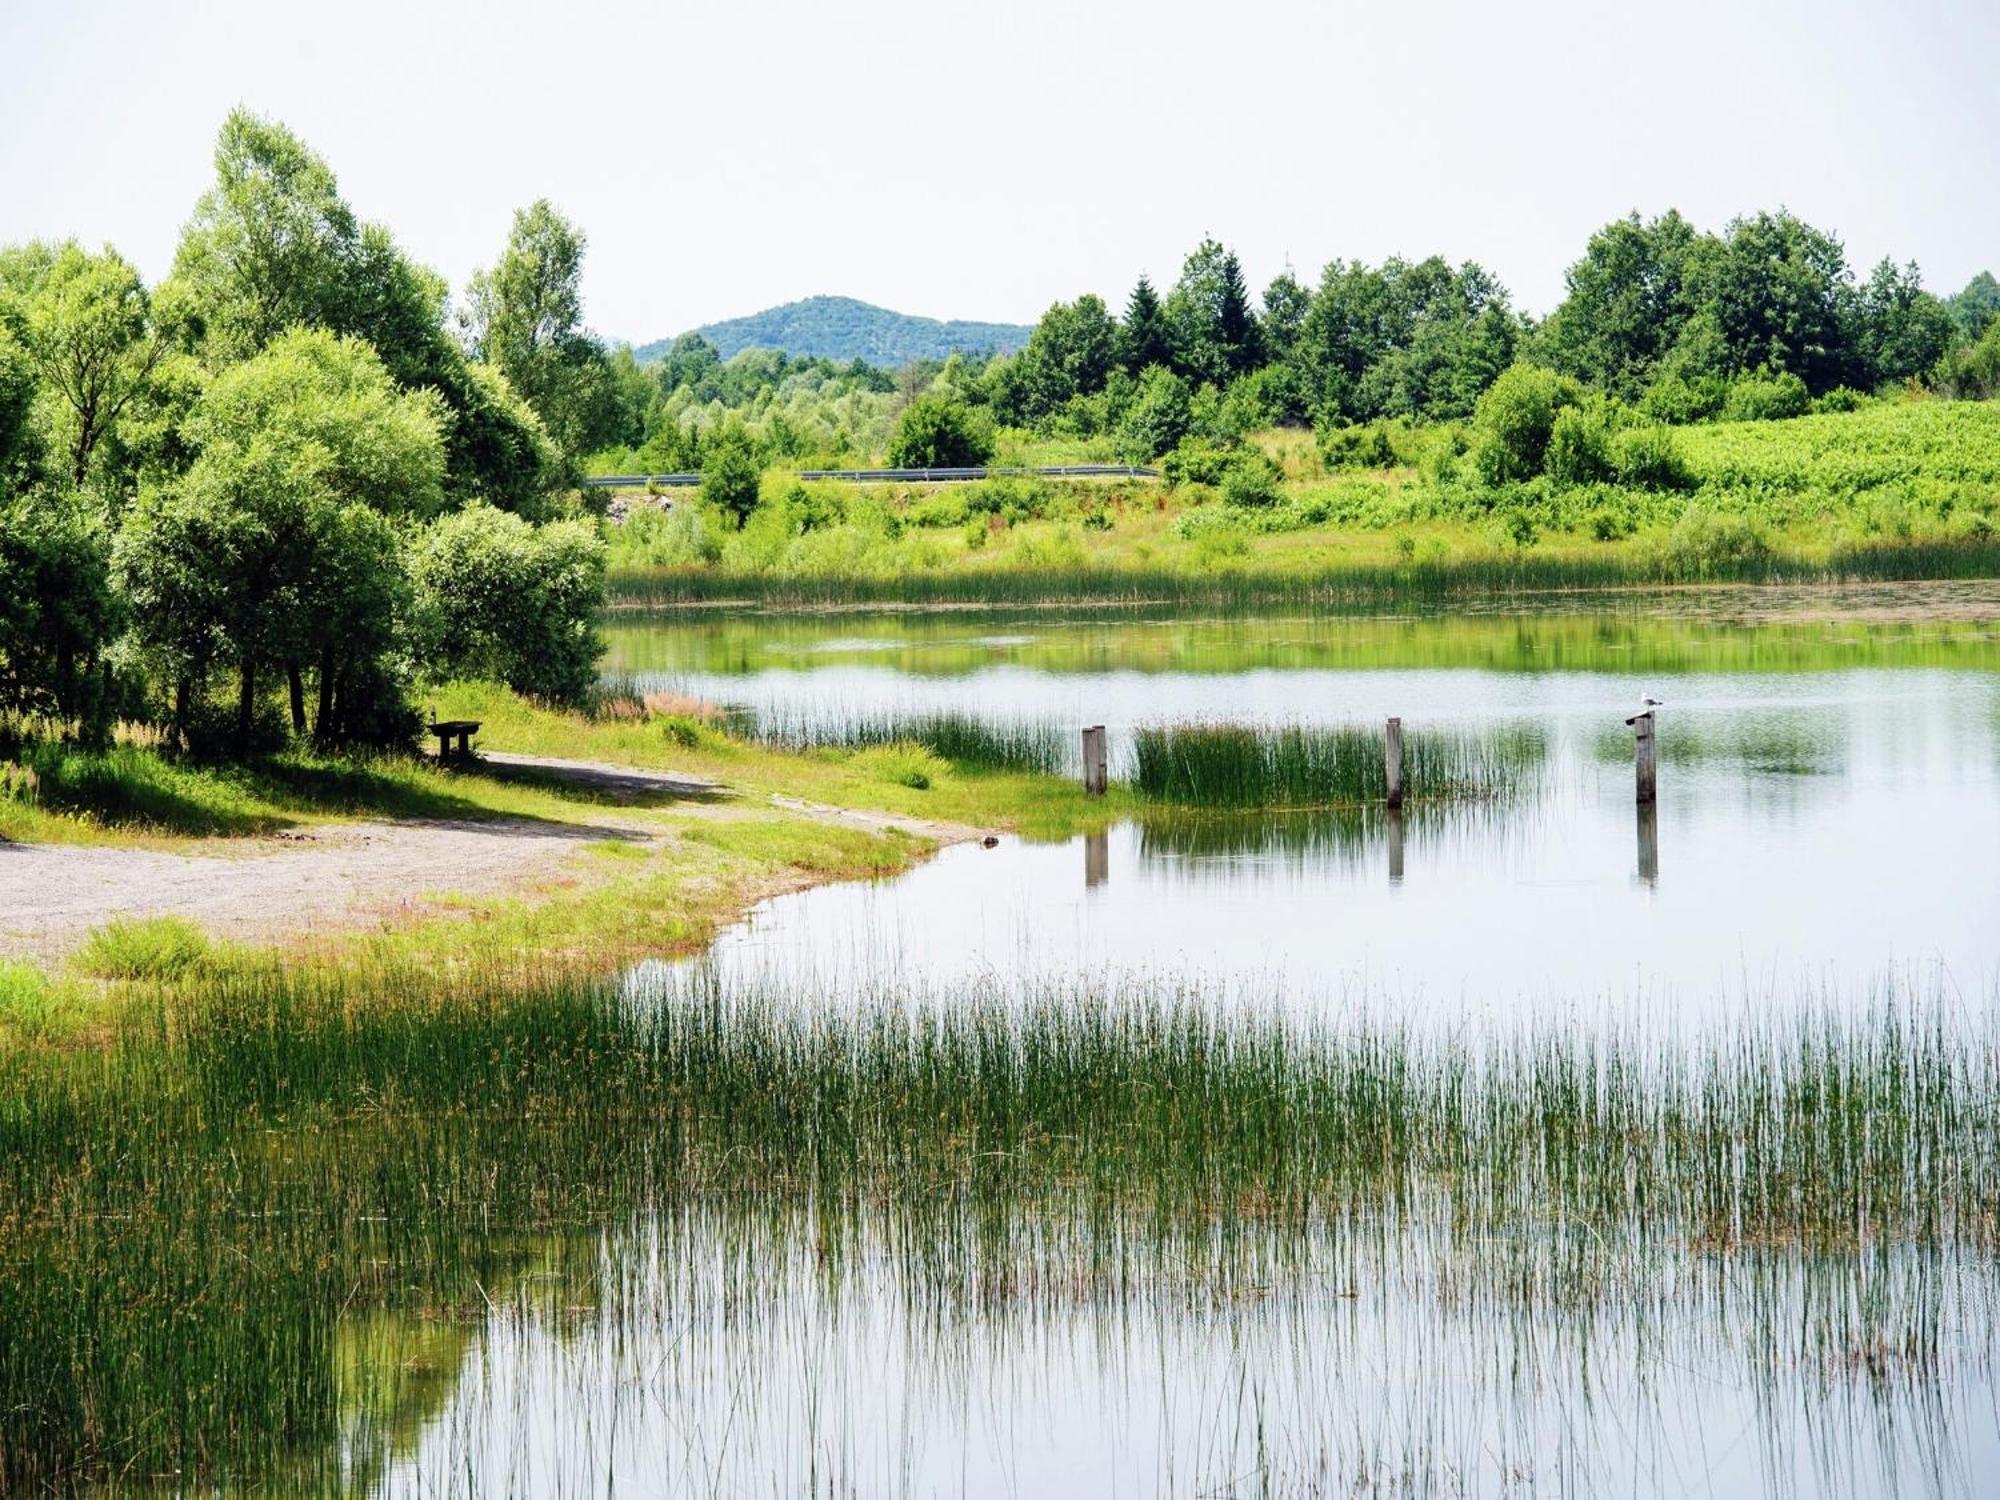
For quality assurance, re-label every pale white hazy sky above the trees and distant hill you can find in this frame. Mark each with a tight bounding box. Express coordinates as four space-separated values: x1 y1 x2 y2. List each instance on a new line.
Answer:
0 0 2000 340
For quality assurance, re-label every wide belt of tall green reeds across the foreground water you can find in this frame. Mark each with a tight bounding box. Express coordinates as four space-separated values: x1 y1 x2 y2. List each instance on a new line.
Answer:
0 970 2000 1492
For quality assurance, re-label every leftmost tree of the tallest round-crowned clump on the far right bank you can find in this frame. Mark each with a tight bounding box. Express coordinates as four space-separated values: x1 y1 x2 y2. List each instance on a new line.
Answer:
1538 210 1716 400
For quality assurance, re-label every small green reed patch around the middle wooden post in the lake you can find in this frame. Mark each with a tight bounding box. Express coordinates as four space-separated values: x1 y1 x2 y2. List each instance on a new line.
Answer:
1132 722 1548 808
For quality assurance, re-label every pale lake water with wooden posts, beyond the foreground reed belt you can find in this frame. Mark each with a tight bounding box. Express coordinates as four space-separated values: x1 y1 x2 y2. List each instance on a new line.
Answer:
614 616 2000 1026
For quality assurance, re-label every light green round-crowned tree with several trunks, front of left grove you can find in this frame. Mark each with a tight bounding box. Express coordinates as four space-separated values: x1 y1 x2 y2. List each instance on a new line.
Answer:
114 328 444 746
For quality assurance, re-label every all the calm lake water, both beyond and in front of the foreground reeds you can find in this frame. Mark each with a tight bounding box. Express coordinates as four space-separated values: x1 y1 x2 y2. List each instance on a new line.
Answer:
328 616 2000 1496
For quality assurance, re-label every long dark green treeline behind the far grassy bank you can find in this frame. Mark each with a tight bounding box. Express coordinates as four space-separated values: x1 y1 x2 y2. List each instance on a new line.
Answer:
604 212 2000 484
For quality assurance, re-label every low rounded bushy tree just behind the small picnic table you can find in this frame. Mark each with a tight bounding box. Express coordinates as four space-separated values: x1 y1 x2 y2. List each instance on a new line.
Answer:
412 506 604 704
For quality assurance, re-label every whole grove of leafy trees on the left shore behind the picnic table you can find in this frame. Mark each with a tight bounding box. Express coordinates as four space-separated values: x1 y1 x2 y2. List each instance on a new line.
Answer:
0 112 608 754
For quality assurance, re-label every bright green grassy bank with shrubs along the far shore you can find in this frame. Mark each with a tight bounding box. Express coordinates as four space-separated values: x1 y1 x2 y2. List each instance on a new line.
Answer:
612 400 2000 610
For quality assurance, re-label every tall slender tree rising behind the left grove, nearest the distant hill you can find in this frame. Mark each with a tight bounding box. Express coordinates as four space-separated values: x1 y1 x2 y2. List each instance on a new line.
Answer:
462 198 616 454
